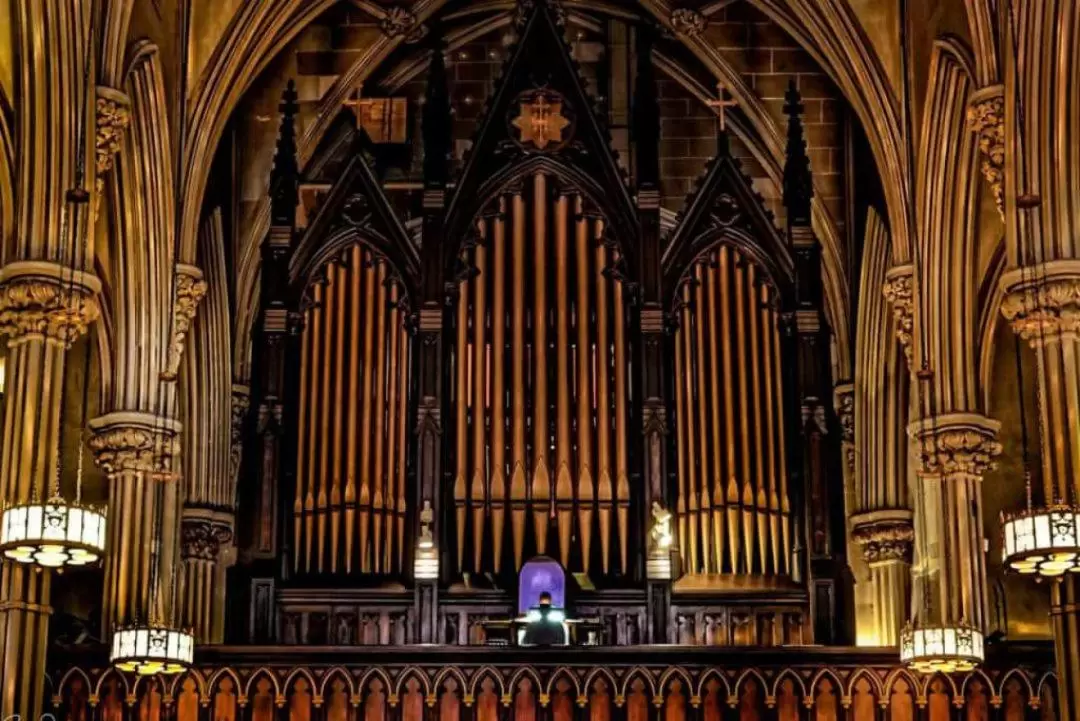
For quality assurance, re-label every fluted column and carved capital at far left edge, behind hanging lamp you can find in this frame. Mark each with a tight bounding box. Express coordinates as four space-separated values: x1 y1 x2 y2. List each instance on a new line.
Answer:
0 261 100 719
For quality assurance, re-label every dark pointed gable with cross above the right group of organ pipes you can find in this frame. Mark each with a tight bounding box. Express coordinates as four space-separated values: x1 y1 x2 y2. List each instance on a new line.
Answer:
663 131 794 297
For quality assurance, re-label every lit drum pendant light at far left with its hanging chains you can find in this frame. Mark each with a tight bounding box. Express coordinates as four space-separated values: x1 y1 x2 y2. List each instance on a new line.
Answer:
0 12 106 569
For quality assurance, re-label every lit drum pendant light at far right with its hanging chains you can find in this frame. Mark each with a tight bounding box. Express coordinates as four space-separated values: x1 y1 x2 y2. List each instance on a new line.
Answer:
1001 0 1080 579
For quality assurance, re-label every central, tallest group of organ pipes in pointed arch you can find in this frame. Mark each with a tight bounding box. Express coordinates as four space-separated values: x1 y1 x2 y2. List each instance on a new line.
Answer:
450 174 631 574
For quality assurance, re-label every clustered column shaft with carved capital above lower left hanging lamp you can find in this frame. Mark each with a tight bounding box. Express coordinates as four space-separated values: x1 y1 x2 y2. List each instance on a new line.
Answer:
89 411 180 638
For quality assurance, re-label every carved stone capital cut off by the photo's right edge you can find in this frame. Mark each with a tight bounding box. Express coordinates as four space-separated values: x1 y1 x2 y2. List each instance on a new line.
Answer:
1001 259 1080 346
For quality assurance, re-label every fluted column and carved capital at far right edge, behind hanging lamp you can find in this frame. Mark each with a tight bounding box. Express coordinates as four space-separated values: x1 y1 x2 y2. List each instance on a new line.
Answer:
1001 259 1080 719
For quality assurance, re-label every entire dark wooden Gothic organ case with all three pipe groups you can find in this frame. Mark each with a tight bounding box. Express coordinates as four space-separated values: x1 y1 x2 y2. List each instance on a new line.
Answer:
238 1 847 645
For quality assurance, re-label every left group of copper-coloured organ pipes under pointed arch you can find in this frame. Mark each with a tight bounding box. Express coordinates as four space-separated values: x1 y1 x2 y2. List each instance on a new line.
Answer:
292 244 409 574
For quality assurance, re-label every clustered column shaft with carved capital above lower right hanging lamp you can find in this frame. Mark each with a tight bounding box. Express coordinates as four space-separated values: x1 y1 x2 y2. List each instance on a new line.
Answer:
908 413 1001 629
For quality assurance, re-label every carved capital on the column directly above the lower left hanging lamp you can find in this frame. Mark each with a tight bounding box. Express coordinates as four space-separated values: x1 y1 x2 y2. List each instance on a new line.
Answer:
90 410 181 478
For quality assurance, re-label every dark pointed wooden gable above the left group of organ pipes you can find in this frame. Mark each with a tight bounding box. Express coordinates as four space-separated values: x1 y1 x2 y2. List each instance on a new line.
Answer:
289 119 420 296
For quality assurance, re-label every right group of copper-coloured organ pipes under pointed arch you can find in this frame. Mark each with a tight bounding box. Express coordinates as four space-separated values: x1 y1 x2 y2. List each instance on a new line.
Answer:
675 246 792 575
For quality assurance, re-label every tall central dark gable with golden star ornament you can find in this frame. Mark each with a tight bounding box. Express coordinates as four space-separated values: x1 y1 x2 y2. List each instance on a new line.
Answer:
447 0 637 259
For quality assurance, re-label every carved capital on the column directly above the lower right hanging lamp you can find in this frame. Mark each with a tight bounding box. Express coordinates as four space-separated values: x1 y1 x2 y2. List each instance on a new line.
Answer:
907 413 1001 479
